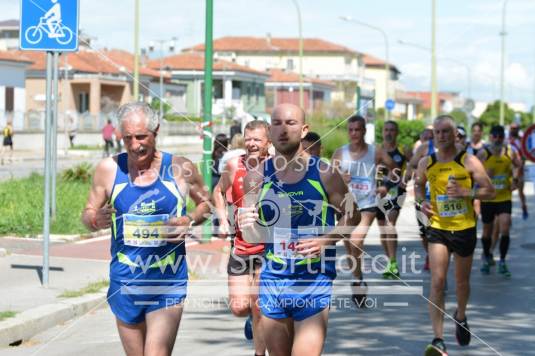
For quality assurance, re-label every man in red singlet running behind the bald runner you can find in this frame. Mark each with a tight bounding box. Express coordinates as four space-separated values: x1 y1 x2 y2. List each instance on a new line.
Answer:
214 120 270 355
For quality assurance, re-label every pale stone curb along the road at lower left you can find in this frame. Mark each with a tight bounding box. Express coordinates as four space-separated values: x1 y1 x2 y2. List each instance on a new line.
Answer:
0 290 106 347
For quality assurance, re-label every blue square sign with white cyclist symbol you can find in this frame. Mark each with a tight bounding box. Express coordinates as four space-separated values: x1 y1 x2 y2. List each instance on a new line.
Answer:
19 0 80 52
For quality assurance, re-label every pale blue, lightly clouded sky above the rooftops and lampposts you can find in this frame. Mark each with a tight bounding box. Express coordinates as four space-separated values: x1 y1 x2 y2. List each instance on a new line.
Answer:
4 0 535 109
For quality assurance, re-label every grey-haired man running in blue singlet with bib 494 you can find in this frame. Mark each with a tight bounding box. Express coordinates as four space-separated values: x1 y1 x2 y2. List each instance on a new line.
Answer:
82 103 210 355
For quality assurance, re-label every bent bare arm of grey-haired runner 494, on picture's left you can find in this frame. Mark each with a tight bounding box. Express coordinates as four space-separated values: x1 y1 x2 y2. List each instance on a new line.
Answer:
82 157 117 231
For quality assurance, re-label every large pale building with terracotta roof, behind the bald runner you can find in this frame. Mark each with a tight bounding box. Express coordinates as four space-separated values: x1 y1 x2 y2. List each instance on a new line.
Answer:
184 35 399 109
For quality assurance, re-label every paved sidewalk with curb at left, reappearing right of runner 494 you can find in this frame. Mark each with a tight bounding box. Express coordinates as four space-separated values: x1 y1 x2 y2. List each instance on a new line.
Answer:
0 237 229 347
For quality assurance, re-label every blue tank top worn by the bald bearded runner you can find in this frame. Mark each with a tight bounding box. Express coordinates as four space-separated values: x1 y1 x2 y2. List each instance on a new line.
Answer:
259 157 336 278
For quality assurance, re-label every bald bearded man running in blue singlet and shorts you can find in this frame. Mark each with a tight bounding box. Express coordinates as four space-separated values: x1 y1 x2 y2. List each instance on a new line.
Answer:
238 104 357 356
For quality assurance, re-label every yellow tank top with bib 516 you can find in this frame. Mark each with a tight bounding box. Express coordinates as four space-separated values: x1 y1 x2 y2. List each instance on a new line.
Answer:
426 151 476 231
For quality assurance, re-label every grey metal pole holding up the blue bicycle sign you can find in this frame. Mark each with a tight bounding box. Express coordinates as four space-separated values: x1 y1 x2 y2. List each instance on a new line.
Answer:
42 52 53 287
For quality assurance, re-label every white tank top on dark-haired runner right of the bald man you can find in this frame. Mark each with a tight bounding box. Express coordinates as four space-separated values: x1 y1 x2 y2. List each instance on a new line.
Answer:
340 145 377 210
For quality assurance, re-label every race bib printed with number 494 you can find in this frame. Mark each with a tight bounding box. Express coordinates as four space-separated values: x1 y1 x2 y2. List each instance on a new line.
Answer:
123 214 169 247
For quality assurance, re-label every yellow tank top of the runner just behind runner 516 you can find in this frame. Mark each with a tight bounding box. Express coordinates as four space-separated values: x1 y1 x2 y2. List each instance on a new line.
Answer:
483 145 513 203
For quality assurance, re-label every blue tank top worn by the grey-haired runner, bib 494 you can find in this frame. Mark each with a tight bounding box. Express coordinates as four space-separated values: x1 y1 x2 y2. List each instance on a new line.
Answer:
110 152 187 280
